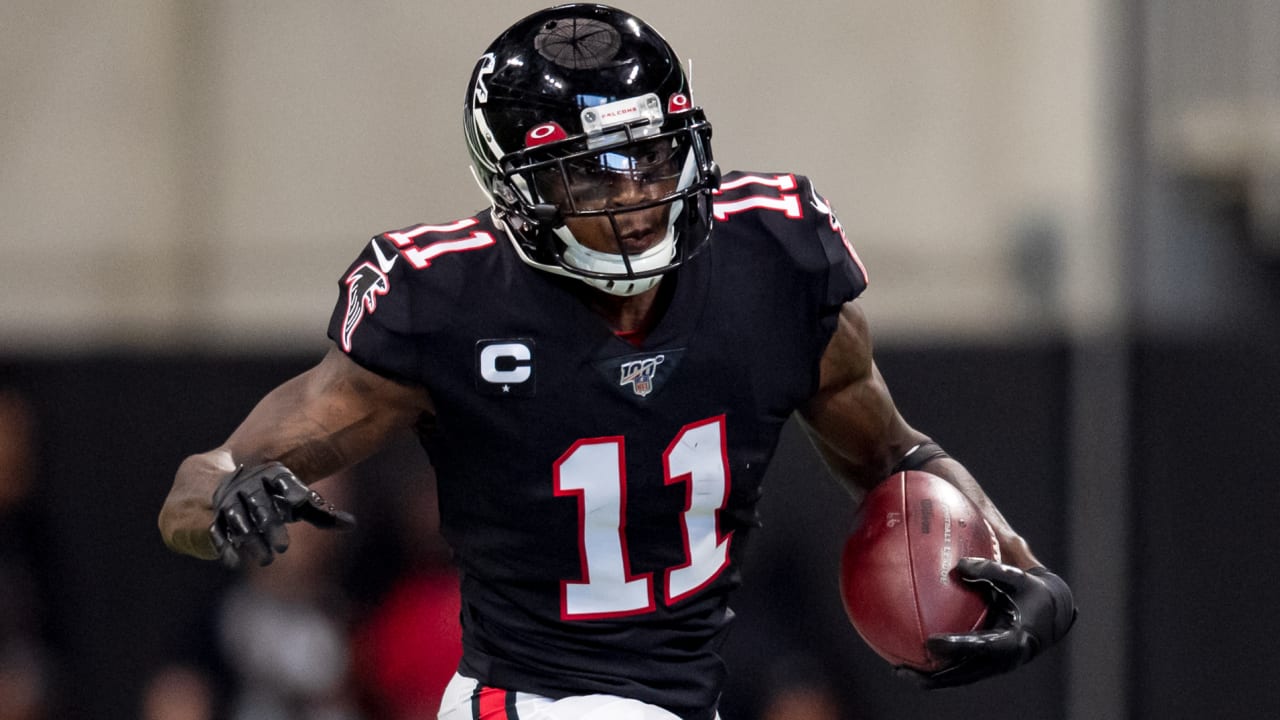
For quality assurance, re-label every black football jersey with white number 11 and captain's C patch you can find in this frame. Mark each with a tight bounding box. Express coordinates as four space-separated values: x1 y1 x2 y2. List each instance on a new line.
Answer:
329 173 867 719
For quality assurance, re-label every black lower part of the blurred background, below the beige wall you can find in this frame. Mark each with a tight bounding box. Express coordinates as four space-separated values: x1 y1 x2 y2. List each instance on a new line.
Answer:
6 326 1280 720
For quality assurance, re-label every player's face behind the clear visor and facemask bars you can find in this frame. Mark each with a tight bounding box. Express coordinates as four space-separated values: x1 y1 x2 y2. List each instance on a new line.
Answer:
539 138 687 255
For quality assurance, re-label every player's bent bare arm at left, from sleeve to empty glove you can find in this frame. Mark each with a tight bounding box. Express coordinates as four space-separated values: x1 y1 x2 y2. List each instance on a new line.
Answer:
159 347 431 560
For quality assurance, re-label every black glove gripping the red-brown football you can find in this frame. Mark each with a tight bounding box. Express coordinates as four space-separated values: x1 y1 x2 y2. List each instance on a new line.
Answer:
897 557 1075 689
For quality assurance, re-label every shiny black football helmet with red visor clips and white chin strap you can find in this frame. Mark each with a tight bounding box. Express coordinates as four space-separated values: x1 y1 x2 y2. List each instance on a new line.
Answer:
465 4 719 296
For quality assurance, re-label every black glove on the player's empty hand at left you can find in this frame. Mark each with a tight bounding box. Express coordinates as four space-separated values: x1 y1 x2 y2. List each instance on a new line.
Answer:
209 462 356 568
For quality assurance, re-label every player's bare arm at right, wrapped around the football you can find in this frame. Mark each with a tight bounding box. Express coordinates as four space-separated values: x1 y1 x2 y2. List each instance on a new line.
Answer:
801 301 1039 569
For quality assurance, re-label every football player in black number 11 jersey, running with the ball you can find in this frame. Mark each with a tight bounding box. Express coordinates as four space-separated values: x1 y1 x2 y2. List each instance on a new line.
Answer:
160 4 1074 720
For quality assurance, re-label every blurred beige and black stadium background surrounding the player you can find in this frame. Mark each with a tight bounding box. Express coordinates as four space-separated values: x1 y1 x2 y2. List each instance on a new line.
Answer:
0 0 1280 720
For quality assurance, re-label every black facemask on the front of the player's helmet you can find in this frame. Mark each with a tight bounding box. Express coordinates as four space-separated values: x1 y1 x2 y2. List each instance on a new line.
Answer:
494 95 714 296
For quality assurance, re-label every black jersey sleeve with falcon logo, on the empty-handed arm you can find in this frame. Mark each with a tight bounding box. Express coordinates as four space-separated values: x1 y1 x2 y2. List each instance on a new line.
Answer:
329 234 422 380
